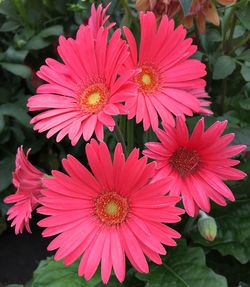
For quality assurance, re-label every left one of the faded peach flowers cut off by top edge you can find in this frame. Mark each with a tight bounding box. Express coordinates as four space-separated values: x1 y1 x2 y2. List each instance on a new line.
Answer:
136 0 180 19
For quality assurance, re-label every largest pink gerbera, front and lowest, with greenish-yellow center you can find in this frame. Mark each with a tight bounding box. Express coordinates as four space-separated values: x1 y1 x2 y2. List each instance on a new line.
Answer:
38 140 183 283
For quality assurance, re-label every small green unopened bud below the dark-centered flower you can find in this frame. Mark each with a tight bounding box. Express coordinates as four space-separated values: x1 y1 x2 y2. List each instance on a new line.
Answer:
198 211 217 241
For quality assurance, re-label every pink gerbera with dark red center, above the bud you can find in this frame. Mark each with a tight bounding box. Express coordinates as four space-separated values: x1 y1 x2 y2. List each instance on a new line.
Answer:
144 117 246 216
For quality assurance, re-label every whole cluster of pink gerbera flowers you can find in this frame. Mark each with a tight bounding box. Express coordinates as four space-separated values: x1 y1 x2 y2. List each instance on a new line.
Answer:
5 2 245 283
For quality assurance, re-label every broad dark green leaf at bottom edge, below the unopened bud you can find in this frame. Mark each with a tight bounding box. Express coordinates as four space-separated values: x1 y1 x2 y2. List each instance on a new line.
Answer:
137 240 227 287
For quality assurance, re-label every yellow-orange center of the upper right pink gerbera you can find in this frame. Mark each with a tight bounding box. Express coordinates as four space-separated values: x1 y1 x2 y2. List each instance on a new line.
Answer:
135 64 159 95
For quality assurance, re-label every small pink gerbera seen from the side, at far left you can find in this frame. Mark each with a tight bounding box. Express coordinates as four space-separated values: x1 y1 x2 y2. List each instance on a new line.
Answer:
4 146 44 234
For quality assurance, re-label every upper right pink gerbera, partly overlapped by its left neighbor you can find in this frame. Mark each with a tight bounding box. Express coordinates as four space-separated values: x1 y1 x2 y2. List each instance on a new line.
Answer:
124 12 206 130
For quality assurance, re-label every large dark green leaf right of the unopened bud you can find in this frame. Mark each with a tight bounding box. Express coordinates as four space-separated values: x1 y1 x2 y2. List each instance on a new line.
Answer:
193 198 250 264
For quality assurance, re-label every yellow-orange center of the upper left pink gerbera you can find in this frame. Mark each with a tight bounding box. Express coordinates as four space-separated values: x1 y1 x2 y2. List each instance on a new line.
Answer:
79 83 108 113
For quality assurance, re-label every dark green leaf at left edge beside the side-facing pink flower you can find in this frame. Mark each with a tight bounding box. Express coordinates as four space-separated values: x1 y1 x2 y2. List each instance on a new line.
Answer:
0 156 15 191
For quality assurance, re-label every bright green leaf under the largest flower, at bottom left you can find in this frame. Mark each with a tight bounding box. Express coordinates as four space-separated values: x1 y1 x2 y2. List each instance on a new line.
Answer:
31 258 101 287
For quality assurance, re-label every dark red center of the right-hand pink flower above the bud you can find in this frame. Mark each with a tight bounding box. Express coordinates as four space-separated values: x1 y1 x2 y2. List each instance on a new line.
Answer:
169 147 200 177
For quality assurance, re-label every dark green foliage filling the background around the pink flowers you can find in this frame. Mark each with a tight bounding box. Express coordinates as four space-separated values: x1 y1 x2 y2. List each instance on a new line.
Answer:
0 0 250 287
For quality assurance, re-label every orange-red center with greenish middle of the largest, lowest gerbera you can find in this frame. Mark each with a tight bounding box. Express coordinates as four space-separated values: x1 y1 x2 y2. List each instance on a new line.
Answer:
94 191 129 225
